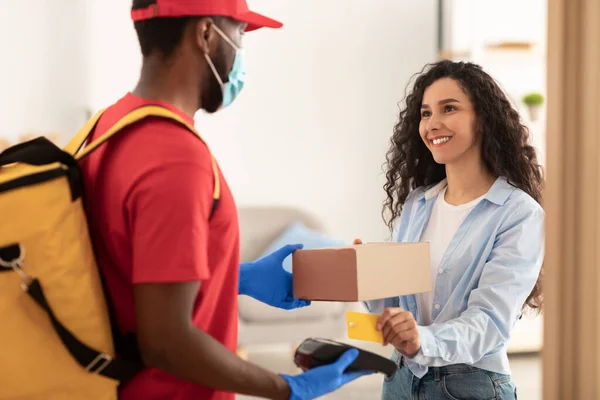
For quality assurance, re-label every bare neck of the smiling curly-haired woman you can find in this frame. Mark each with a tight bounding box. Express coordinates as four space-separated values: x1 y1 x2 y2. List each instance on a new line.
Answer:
446 151 496 205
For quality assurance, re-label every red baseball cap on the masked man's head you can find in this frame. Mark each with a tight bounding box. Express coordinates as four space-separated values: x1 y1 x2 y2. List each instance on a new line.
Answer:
131 0 283 31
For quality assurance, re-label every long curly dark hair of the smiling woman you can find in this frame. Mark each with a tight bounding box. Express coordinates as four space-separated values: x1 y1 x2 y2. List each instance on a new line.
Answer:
382 60 544 310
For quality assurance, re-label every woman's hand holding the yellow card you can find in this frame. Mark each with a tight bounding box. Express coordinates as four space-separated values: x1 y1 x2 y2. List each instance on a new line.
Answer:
377 308 421 358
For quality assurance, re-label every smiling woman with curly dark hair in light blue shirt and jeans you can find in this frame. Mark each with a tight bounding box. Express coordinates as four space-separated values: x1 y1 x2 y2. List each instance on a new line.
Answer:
367 61 544 400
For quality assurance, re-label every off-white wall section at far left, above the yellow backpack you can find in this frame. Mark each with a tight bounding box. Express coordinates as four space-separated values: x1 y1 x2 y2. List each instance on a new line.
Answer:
0 0 89 143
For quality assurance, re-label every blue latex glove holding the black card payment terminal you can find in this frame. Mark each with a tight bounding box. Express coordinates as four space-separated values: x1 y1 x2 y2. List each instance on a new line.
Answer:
281 349 374 400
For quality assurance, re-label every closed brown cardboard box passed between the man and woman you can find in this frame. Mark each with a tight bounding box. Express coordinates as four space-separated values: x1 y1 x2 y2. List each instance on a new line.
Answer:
292 243 432 302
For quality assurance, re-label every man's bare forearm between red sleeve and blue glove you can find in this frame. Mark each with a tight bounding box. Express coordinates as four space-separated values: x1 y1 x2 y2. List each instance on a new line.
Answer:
135 282 290 399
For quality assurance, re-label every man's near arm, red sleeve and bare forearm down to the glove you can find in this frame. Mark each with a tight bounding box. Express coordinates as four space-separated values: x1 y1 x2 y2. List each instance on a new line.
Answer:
119 130 289 399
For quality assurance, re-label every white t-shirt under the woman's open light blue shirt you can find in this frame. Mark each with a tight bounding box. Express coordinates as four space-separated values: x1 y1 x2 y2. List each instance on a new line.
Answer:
417 188 485 326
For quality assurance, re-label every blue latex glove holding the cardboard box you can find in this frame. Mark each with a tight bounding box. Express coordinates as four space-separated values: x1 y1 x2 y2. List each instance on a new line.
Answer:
238 244 310 310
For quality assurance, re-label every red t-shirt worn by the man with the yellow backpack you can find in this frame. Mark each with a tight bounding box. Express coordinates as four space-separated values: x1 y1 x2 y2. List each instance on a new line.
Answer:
83 94 239 400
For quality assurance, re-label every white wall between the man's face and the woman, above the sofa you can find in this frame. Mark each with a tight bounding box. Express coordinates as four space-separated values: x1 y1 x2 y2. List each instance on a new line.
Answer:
200 0 436 240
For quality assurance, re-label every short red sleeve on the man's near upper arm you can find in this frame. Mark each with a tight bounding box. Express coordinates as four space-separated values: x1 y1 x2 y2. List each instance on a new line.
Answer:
125 158 214 284
